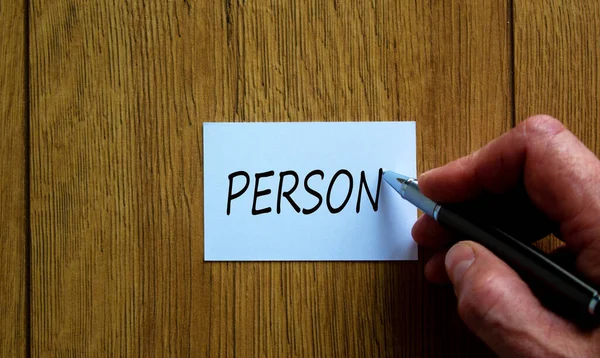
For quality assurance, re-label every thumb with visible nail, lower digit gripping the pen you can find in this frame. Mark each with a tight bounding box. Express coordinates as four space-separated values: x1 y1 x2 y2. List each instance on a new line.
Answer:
445 241 585 357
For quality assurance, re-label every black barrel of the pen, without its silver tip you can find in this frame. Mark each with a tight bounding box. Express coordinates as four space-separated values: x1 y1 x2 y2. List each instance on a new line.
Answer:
436 206 598 321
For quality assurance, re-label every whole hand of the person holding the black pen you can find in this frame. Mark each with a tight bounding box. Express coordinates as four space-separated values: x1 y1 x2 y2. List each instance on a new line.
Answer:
413 116 600 357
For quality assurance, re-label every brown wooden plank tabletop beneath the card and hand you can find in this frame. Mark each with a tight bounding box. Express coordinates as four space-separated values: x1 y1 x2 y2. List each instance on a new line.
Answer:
0 0 600 357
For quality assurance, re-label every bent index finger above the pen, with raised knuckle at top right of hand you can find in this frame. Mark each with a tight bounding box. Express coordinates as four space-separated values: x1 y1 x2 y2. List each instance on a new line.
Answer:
419 116 600 255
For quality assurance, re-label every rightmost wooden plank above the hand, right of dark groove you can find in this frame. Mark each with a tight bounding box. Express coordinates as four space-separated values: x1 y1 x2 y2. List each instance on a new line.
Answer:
514 0 600 251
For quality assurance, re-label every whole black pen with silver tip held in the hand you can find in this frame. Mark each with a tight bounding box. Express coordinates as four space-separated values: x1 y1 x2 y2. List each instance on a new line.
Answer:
383 171 600 322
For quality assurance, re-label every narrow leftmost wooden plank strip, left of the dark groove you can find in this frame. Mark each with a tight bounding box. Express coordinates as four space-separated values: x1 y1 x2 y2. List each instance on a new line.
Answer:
0 1 29 357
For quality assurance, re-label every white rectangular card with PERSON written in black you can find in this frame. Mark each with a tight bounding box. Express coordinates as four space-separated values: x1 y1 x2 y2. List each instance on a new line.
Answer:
204 122 417 261
